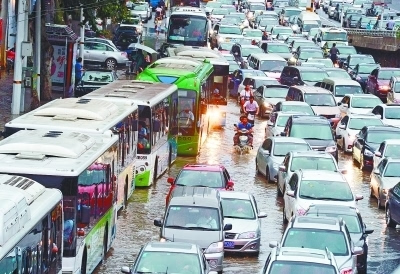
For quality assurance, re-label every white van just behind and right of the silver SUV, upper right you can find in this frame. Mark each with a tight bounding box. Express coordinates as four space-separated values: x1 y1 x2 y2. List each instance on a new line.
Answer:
315 77 363 102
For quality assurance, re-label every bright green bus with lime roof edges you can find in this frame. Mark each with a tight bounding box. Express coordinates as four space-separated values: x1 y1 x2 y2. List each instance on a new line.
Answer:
137 56 214 156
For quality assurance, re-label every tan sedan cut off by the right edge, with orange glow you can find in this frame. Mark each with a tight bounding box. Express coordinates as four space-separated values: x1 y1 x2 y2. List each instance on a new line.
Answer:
370 158 400 208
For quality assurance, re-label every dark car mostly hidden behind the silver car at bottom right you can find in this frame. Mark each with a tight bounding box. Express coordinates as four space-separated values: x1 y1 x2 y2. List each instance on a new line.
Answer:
305 204 374 273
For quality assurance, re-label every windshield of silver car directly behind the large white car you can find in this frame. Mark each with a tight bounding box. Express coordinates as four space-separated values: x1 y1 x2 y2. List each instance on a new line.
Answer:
290 156 337 172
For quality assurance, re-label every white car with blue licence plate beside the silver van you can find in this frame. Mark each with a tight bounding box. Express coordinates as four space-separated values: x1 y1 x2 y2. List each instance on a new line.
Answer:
220 191 267 255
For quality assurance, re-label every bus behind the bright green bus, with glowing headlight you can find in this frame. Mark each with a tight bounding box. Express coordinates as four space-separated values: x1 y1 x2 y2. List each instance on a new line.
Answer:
167 46 229 127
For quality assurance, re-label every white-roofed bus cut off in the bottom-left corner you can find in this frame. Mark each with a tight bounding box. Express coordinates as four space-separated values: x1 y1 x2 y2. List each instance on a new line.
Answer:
0 174 63 274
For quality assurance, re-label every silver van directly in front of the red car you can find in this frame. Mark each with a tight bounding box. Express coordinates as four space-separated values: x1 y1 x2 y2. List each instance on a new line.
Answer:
154 186 232 272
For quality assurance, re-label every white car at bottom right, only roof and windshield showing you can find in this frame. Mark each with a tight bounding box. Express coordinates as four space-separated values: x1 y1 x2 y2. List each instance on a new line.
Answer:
261 246 340 274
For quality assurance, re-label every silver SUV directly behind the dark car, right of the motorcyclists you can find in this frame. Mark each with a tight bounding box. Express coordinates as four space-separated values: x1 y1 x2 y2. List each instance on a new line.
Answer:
286 86 340 125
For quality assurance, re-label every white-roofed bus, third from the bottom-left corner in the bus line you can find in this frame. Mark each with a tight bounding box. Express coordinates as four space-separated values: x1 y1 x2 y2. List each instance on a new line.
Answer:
3 98 138 210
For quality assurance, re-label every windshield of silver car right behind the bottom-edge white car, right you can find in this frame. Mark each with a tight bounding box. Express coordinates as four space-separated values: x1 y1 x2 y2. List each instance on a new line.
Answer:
282 228 349 256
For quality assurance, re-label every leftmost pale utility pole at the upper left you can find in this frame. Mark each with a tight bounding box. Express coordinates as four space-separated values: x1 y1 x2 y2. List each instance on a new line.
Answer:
11 0 28 114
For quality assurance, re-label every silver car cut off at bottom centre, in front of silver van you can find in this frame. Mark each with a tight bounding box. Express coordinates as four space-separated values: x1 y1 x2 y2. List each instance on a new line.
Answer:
121 242 211 274
